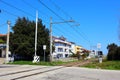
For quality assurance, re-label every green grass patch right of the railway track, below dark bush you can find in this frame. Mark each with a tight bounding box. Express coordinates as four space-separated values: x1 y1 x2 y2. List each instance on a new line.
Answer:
82 60 120 70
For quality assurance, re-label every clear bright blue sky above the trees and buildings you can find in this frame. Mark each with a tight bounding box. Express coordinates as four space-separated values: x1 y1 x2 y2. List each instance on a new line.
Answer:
0 0 120 54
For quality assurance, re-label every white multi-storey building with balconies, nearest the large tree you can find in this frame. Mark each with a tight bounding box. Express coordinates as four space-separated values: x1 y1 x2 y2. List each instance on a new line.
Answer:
53 36 74 58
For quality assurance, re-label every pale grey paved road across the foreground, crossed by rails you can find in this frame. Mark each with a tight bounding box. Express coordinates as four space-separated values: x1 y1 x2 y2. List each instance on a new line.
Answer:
0 65 120 80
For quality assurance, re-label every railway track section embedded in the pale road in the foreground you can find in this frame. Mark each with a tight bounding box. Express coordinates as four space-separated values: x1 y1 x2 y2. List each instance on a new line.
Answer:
0 66 64 80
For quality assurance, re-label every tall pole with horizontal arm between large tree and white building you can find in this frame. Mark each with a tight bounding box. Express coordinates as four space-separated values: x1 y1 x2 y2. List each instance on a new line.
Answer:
50 17 74 62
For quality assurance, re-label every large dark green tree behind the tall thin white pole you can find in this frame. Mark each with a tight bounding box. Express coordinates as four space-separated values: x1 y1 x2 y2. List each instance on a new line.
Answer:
10 17 49 60
